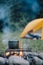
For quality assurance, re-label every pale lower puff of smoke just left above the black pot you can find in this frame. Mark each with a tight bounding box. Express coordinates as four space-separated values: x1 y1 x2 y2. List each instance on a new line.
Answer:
2 27 11 49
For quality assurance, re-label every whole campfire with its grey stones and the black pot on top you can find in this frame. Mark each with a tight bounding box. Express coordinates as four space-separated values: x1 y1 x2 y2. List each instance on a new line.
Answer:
0 41 43 65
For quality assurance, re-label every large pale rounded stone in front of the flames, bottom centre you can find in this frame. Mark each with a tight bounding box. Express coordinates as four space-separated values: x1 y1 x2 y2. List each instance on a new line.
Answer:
8 56 29 65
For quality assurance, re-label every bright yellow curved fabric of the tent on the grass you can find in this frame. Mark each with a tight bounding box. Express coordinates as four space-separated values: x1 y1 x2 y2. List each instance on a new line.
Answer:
20 18 43 40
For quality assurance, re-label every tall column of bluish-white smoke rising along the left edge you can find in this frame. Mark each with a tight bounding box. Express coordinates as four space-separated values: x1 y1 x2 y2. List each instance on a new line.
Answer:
0 4 11 47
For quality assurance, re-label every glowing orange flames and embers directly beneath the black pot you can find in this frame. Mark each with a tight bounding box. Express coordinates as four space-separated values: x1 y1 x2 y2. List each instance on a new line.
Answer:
5 48 24 57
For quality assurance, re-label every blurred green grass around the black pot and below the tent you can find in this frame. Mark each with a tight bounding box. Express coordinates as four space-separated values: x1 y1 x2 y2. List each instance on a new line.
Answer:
0 31 43 52
